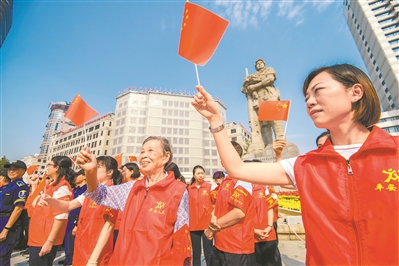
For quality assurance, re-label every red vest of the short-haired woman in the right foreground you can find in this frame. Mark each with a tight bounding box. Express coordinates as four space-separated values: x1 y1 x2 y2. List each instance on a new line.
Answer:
294 127 399 265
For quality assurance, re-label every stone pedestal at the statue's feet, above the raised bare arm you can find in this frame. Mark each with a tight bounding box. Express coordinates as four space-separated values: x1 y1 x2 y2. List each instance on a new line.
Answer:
242 142 300 163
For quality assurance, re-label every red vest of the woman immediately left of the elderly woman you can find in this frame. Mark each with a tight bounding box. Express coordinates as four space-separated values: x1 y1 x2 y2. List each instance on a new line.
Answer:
73 180 118 265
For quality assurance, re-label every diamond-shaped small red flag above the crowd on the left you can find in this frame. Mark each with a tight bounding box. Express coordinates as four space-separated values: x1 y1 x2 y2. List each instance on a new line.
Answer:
64 94 98 126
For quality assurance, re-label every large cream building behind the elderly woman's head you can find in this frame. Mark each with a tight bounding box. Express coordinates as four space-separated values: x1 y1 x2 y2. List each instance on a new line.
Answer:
111 87 226 177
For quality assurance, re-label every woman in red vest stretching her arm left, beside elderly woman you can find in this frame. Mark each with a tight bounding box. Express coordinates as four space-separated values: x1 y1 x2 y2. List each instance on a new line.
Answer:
41 156 122 265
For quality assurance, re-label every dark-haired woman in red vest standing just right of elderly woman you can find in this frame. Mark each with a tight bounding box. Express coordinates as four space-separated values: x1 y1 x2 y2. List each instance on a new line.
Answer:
188 165 213 266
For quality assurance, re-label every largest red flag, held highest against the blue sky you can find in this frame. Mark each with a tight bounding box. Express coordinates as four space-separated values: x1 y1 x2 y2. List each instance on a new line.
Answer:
178 2 229 66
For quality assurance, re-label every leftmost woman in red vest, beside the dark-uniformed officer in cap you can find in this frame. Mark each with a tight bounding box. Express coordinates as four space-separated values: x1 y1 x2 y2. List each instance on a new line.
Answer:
28 156 75 266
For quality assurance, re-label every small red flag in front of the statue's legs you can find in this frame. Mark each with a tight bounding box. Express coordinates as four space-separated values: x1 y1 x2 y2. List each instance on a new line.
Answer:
258 101 291 121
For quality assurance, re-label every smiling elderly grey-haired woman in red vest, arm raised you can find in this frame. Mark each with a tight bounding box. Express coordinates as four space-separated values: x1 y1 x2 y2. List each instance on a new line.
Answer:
76 137 191 265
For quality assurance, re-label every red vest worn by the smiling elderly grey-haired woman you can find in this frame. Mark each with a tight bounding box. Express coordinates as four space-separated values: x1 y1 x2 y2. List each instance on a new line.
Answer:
109 171 191 265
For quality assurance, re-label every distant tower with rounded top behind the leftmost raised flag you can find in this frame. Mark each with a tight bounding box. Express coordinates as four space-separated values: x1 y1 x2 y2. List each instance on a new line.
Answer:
39 102 74 158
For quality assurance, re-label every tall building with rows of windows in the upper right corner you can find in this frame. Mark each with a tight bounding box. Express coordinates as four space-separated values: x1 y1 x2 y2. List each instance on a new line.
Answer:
344 0 399 111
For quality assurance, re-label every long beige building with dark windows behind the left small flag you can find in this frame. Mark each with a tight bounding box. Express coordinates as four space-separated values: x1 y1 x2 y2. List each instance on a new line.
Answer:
47 113 115 169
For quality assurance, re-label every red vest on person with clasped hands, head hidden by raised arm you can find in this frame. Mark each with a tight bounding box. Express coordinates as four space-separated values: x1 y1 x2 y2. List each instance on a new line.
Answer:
214 176 255 254
